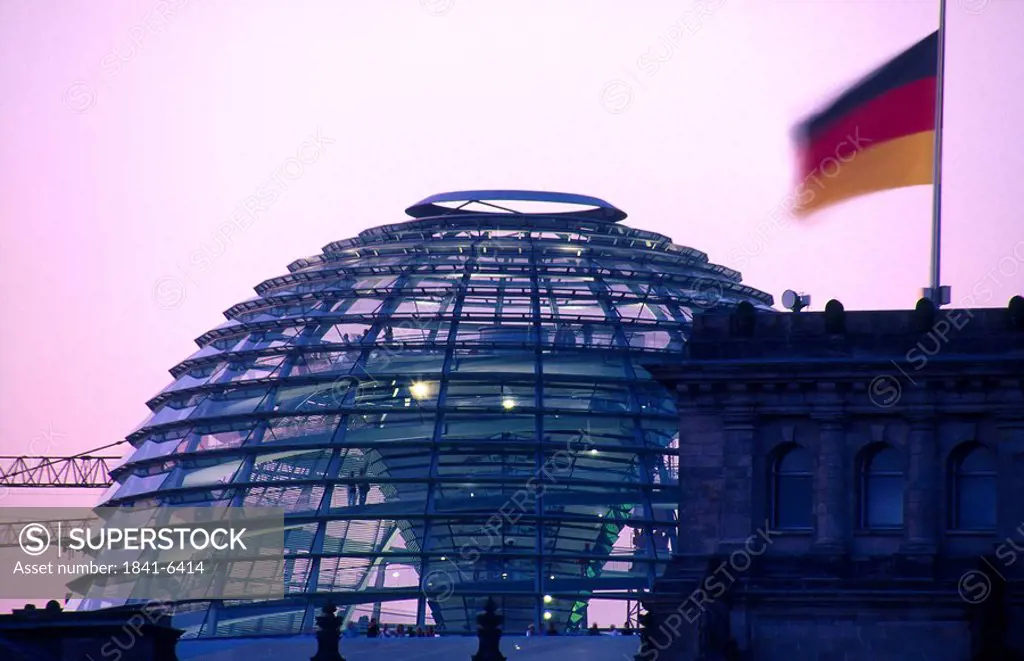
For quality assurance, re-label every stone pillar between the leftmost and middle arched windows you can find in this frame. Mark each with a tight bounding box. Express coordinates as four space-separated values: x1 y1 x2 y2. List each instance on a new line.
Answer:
814 419 851 556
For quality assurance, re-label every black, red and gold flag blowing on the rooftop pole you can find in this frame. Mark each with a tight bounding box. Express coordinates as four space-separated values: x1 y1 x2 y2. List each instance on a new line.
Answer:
794 32 939 216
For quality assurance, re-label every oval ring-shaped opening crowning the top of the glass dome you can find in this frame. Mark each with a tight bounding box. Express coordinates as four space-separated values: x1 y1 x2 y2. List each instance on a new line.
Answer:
406 190 626 222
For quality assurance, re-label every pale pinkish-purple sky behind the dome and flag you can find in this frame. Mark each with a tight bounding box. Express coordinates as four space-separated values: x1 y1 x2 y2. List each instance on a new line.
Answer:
0 0 1024 622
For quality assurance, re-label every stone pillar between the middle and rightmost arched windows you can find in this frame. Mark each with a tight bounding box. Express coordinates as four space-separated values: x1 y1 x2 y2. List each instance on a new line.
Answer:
902 413 940 556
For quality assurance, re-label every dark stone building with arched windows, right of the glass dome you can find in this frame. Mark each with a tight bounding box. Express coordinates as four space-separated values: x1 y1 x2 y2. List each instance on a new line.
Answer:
637 297 1024 661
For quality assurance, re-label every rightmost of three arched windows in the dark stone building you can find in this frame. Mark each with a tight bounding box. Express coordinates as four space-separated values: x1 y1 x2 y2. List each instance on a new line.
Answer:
949 443 995 530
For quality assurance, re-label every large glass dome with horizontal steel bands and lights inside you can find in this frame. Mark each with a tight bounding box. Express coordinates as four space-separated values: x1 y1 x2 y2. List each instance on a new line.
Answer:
82 191 772 637
